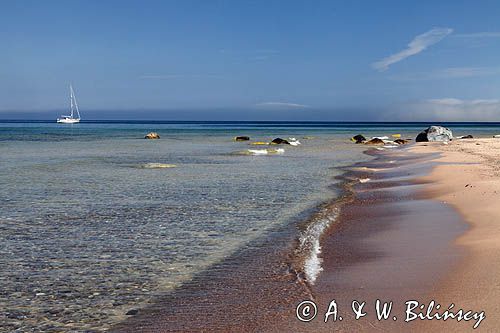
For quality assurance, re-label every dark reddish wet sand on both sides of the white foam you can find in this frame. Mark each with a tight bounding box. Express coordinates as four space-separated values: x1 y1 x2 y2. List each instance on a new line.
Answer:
114 149 472 332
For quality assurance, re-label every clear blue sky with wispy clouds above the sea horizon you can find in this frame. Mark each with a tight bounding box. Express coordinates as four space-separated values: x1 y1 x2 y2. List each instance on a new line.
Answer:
0 0 500 121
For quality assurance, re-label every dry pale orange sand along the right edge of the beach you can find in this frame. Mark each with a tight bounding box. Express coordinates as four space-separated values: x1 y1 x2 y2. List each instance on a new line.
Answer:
411 139 500 332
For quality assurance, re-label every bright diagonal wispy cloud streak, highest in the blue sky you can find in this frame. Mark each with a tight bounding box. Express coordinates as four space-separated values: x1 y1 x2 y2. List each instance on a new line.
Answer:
372 28 453 72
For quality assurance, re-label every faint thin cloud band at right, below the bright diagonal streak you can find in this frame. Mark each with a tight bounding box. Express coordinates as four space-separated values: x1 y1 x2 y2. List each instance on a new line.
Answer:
390 67 500 81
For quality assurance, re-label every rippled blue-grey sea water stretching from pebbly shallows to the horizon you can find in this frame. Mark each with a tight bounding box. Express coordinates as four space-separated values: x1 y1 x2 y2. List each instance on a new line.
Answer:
0 122 500 331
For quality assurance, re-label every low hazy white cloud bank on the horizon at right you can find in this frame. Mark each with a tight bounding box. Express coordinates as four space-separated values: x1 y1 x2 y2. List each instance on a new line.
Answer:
386 98 500 121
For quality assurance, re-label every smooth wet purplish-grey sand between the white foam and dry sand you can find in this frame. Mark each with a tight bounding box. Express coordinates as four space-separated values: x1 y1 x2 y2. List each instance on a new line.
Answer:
300 148 467 332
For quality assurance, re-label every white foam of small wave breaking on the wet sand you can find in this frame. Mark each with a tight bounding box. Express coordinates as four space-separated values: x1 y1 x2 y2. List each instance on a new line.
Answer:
299 213 337 284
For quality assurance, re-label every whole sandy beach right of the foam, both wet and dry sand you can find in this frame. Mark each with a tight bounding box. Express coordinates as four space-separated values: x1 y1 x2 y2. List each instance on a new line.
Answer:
308 138 500 332
